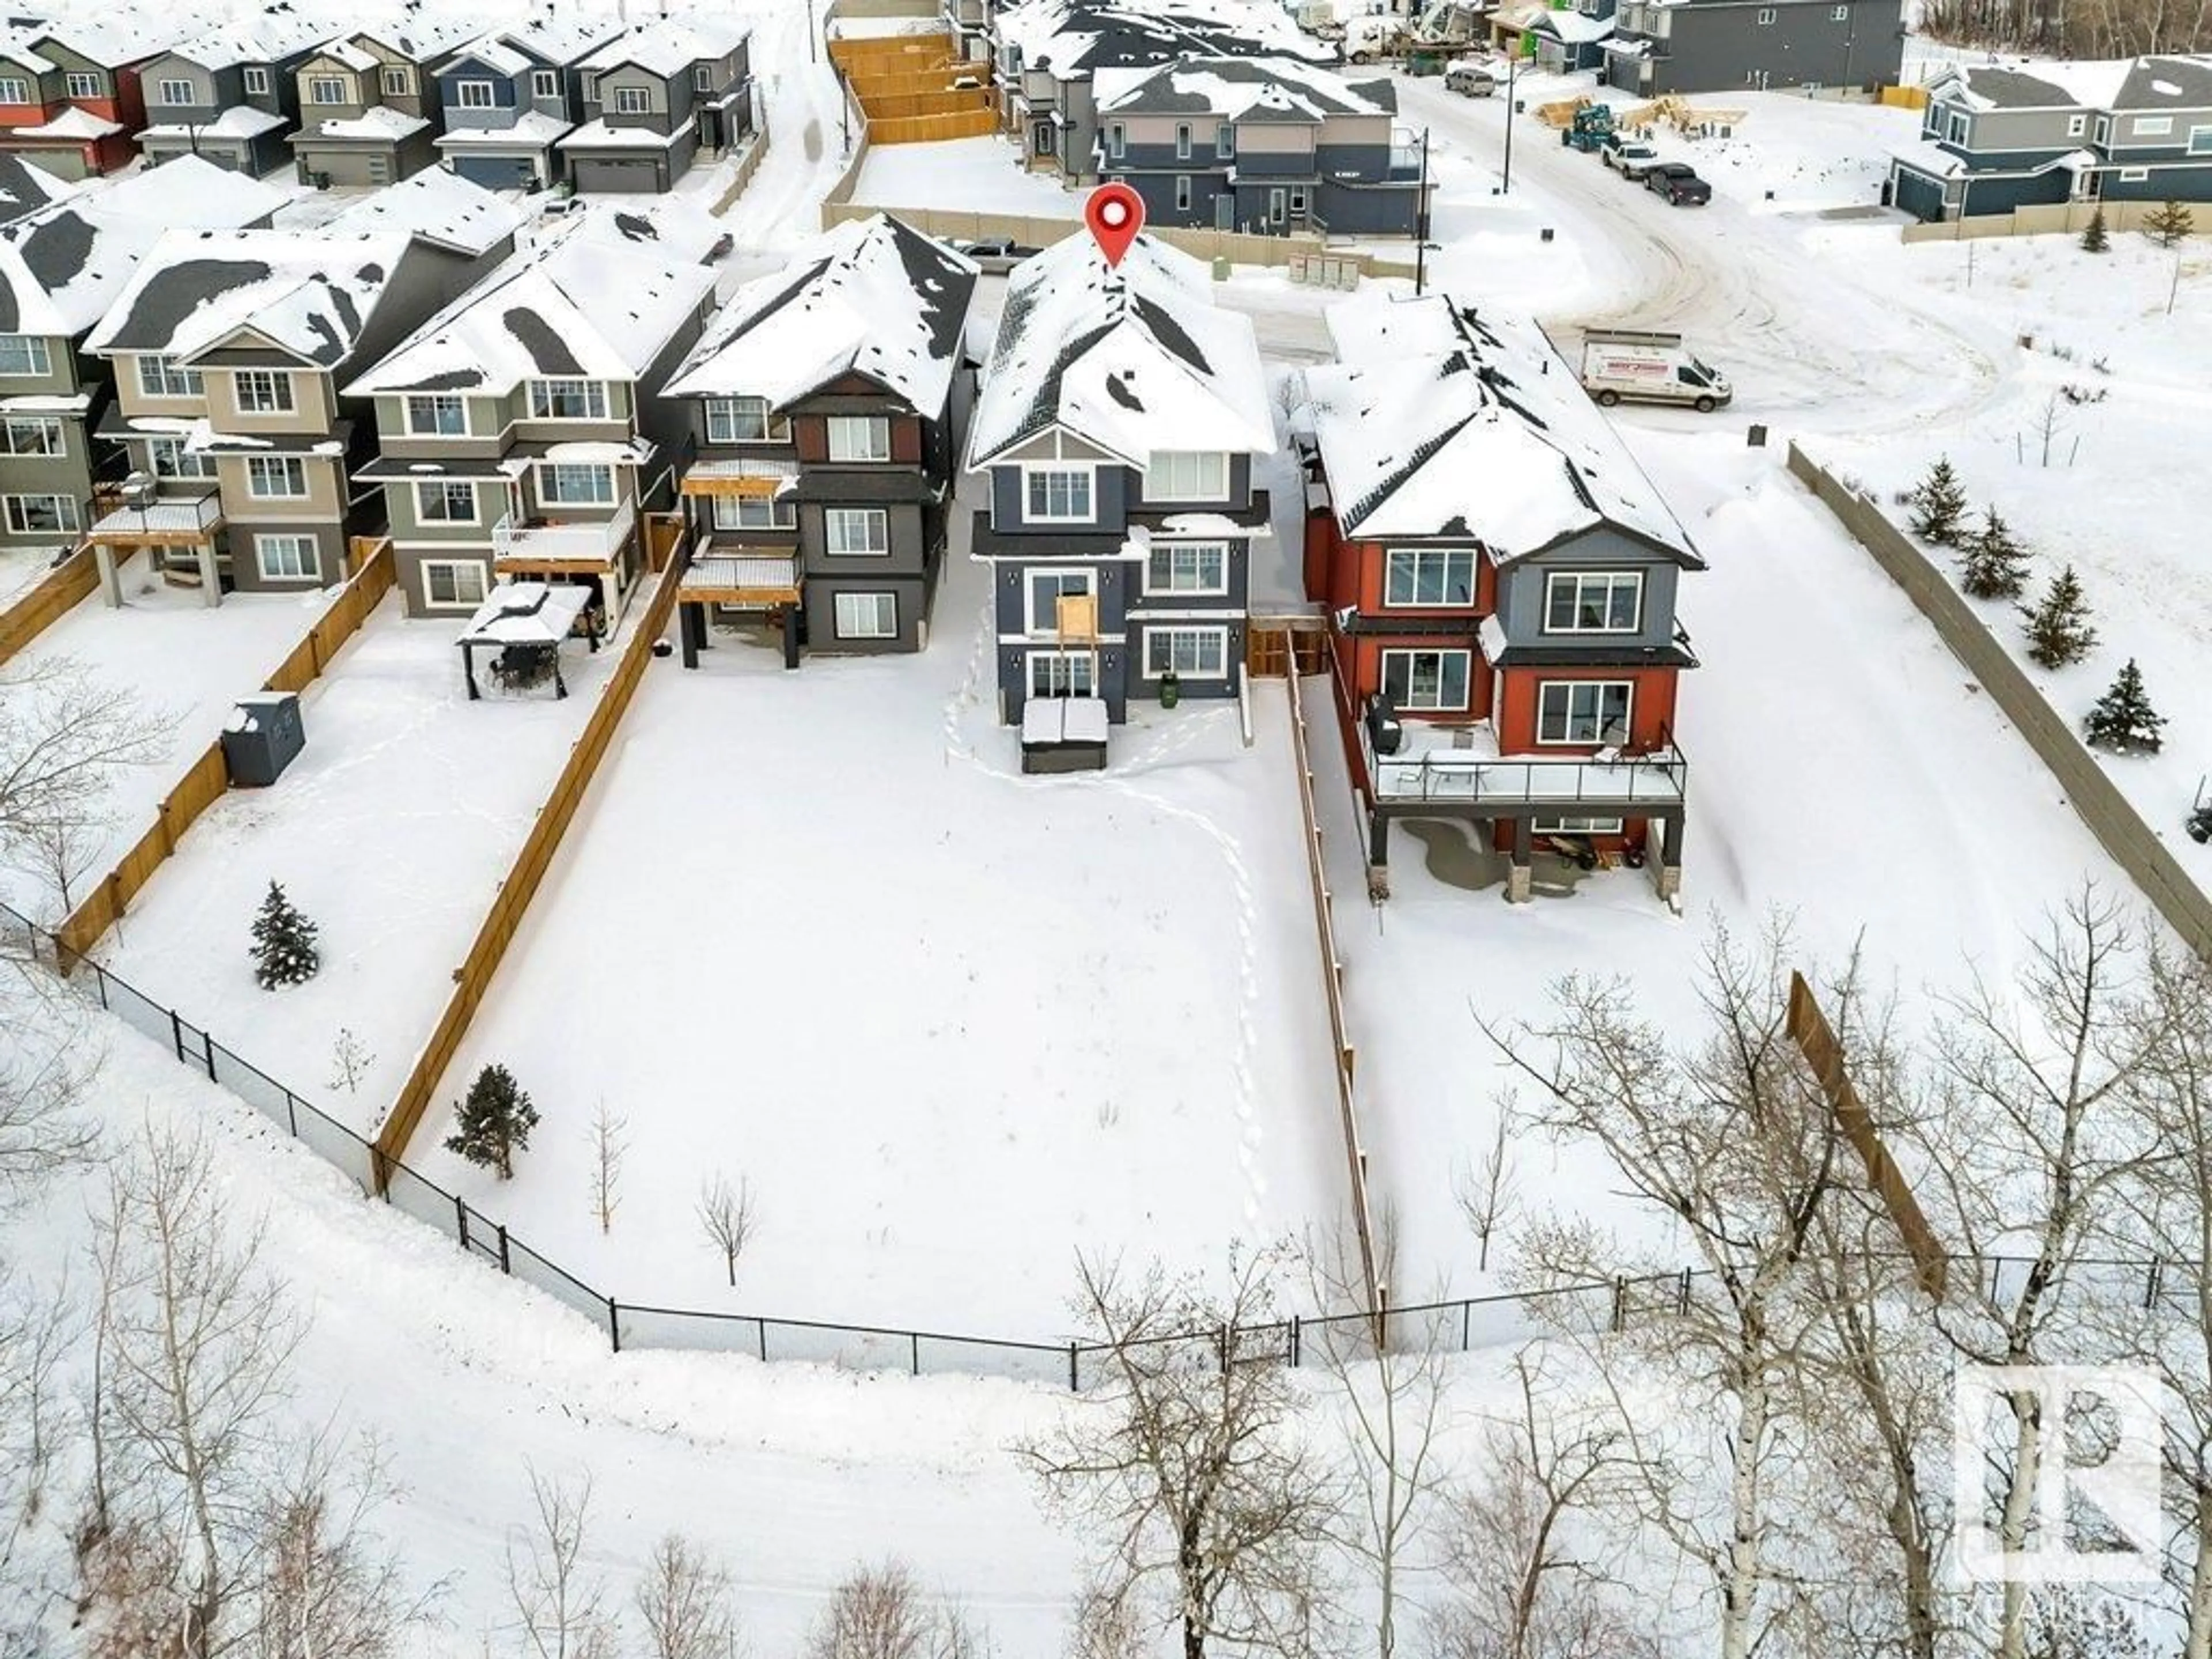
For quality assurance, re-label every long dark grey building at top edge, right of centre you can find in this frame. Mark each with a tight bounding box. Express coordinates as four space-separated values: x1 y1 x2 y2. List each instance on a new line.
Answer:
1601 0 1904 97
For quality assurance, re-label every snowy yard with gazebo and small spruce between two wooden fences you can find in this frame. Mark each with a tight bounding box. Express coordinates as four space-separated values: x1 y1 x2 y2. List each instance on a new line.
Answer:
100 595 643 1132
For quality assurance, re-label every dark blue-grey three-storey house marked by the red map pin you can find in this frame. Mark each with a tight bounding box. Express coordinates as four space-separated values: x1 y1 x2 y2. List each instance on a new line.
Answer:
967 237 1274 724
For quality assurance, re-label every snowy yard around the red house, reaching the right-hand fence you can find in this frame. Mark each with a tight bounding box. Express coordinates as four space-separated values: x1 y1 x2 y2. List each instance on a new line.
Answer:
1314 434 2133 1298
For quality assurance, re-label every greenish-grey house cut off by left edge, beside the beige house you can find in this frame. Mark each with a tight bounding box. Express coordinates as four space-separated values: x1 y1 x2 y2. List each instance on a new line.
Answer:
0 159 285 559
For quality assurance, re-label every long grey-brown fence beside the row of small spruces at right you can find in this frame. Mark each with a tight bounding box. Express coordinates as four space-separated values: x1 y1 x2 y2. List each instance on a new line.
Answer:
1790 442 2212 956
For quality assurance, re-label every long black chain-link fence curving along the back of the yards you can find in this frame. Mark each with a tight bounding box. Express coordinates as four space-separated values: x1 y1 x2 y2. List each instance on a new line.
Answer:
0 905 2196 1391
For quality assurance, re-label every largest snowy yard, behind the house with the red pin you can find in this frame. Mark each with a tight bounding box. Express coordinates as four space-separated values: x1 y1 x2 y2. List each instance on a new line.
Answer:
411 542 1347 1340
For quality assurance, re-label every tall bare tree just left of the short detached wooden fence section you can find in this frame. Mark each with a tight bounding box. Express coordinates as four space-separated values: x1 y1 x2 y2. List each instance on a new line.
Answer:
1484 927 1858 1659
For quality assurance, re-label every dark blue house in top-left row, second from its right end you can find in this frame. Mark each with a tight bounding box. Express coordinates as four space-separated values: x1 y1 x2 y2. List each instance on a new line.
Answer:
435 16 622 190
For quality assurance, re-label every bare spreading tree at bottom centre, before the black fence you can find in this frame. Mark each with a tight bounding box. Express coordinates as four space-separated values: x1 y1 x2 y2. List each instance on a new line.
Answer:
1020 1252 1334 1659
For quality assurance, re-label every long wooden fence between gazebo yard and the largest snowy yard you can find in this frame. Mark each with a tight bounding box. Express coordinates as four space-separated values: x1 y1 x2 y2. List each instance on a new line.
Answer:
376 553 684 1192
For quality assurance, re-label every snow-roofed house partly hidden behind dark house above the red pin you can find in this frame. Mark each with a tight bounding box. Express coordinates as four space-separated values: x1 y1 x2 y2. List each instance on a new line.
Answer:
987 0 1336 186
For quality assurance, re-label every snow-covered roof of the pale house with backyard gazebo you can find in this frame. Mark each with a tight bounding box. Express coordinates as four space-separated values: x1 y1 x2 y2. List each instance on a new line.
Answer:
345 225 714 398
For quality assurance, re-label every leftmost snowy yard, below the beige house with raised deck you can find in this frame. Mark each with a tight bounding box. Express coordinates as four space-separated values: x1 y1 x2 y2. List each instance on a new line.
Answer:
0 558 329 920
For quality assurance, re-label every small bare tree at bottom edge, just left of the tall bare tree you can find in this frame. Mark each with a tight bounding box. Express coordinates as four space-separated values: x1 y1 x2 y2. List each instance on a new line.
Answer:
1429 1351 1657 1659
